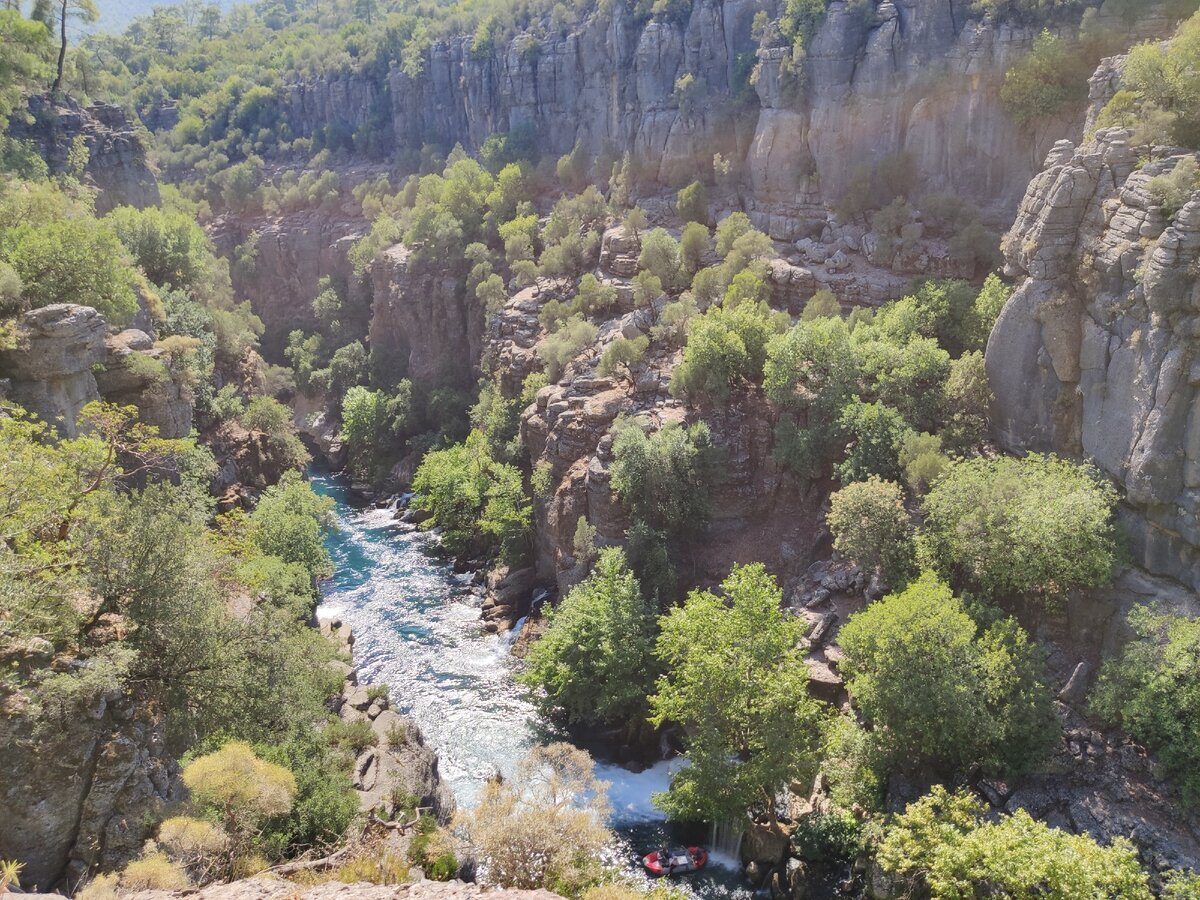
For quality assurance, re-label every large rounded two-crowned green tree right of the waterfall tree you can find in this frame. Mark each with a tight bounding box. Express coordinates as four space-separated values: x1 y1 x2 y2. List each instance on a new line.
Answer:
838 574 1056 772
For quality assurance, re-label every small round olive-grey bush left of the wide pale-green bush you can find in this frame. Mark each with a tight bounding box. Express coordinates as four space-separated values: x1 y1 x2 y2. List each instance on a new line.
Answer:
826 475 914 587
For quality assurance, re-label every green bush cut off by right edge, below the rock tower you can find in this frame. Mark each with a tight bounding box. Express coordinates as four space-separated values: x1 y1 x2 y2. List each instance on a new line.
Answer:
1092 607 1200 805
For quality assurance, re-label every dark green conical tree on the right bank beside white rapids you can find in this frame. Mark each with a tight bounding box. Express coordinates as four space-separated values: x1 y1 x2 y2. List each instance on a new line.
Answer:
521 549 655 726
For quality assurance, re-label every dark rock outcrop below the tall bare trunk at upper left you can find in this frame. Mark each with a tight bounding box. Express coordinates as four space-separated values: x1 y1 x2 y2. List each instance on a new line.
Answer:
8 96 158 214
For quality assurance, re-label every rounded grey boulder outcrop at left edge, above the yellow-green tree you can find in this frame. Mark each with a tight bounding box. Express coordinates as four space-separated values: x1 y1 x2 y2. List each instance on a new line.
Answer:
0 304 106 437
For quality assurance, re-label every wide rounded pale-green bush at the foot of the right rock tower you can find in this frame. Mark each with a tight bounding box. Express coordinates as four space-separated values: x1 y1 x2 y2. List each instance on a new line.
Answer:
919 455 1116 602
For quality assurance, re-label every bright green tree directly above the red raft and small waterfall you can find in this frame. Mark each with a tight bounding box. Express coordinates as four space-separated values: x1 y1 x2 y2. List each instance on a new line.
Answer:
650 563 823 821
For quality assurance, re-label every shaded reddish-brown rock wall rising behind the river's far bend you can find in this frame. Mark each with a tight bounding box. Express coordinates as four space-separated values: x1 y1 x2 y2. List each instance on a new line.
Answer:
370 244 484 385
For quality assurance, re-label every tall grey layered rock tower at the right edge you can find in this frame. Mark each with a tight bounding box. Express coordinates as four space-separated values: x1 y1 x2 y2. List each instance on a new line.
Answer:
988 128 1200 588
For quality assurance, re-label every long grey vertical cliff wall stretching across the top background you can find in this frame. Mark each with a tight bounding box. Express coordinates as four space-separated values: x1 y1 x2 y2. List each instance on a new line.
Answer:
282 0 1168 239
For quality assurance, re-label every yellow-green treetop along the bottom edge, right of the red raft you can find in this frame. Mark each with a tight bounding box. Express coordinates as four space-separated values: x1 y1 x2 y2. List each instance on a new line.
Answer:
877 785 1152 900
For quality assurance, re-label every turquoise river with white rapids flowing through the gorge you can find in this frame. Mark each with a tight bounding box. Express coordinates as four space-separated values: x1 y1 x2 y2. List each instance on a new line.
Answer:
312 470 751 899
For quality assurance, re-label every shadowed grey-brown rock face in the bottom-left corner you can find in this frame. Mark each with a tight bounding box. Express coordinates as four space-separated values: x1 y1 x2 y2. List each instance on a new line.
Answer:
0 695 180 890
